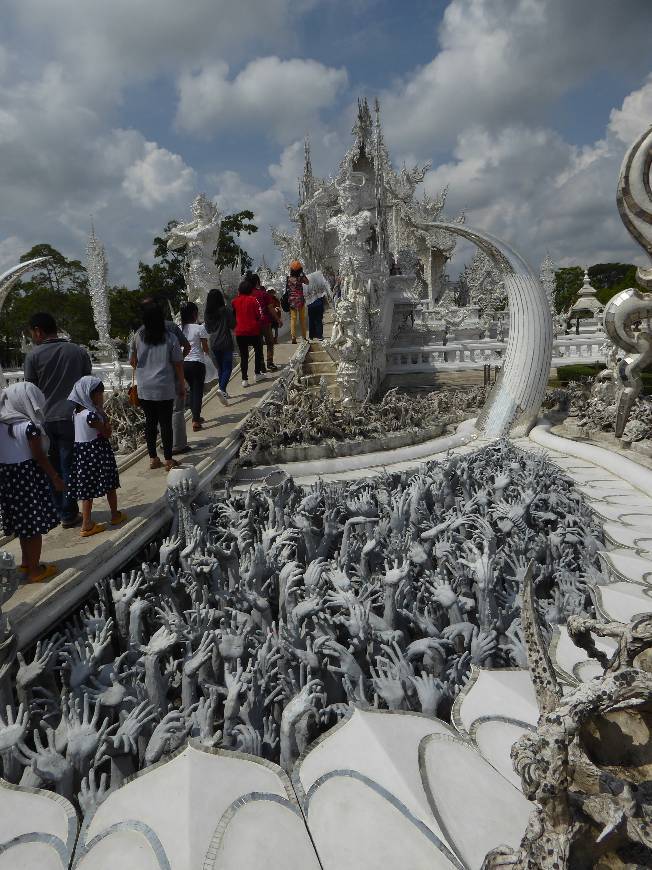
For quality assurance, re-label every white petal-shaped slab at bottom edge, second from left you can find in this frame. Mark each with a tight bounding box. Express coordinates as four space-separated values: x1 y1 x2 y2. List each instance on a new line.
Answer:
78 743 308 870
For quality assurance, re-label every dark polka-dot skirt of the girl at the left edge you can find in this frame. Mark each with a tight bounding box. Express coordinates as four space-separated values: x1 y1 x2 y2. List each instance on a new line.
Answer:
0 459 59 538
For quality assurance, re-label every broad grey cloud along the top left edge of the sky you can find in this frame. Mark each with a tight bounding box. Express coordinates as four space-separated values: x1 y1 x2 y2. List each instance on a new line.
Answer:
5 0 310 102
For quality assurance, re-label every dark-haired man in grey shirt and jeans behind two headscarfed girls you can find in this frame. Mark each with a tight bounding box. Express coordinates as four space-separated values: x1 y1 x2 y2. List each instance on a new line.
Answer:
25 312 93 529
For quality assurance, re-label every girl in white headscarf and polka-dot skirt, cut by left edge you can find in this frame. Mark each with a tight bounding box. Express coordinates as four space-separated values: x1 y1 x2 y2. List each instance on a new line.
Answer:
0 383 65 583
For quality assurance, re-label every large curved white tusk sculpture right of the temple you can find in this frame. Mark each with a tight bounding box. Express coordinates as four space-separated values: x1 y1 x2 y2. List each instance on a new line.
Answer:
431 222 553 438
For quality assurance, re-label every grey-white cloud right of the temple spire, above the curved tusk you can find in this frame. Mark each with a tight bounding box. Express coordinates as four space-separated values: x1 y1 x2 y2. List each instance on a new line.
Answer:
425 101 641 267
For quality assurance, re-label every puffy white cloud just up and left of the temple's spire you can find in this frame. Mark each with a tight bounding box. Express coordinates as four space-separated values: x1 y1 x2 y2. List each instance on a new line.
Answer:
177 57 348 142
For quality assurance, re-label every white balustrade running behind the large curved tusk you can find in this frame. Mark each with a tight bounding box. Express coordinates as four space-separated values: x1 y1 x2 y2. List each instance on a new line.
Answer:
385 334 605 375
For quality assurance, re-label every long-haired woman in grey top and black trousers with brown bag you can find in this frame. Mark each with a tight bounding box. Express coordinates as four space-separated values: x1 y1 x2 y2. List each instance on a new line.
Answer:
131 305 186 471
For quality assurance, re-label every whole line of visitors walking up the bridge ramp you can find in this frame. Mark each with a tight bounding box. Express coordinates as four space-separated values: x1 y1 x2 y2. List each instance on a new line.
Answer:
0 260 324 583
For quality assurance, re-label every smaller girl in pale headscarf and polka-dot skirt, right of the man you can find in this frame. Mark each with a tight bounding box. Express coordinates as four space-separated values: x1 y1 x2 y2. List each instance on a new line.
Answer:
68 375 127 538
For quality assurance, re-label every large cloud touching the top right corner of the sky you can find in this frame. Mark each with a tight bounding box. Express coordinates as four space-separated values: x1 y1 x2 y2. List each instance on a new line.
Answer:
383 0 652 158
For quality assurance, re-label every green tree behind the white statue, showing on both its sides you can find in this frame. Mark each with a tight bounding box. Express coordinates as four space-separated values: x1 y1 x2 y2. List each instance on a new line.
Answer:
138 209 258 311
